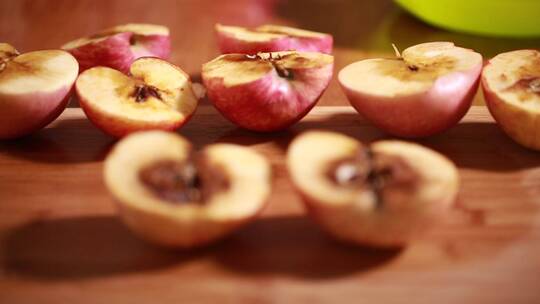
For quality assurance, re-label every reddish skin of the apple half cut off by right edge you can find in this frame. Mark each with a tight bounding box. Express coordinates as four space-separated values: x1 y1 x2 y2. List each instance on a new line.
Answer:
482 70 540 151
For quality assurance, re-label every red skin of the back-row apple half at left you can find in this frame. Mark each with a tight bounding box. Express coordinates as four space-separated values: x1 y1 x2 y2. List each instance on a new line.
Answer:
68 32 171 74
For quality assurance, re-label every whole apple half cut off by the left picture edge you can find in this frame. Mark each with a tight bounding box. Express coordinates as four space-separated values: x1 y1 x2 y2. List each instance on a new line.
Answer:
0 43 79 139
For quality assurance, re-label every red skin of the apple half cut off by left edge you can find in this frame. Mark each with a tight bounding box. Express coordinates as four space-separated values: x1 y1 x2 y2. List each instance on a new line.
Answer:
0 85 73 139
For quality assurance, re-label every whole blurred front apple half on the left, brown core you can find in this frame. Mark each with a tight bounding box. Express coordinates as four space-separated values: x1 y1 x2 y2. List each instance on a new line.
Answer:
104 131 271 248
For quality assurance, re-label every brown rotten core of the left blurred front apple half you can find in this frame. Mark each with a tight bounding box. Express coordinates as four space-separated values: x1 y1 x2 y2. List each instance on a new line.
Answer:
139 157 230 205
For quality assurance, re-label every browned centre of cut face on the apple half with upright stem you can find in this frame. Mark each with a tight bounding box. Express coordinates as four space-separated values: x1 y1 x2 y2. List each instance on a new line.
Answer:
376 56 456 82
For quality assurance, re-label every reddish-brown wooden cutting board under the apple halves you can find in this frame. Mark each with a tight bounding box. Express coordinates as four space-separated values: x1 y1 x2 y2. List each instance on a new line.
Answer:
0 106 540 304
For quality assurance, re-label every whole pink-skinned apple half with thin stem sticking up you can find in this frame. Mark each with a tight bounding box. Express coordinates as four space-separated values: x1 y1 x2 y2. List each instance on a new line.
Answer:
338 42 482 137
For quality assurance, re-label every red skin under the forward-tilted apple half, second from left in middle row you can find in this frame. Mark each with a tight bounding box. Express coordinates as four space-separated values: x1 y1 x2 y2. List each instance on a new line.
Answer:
77 97 195 138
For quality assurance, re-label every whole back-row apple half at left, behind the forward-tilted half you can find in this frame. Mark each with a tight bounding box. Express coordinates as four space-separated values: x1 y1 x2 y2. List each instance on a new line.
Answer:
62 23 171 73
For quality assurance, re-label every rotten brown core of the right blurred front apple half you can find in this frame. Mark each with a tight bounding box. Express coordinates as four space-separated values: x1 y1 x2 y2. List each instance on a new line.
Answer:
326 148 419 206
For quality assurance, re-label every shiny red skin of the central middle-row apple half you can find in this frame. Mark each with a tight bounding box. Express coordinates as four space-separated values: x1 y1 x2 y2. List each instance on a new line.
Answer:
203 64 333 132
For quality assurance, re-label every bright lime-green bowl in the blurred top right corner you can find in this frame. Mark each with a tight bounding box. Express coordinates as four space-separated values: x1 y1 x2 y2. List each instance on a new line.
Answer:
395 0 540 37
